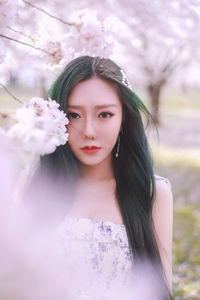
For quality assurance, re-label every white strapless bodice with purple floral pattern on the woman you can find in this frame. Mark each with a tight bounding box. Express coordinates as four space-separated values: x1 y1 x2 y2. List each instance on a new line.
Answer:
57 217 133 300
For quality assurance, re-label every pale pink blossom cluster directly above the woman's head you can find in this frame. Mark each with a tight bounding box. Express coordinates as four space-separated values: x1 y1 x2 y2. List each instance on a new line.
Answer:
35 9 113 72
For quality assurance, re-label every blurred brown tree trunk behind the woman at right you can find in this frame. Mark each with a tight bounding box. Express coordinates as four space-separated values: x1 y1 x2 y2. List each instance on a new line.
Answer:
147 83 162 125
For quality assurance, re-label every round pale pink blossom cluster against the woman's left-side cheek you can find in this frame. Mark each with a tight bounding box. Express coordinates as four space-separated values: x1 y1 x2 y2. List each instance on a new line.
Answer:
7 98 69 155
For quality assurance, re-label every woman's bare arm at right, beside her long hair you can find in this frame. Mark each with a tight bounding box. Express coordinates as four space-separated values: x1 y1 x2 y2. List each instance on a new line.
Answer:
152 176 173 290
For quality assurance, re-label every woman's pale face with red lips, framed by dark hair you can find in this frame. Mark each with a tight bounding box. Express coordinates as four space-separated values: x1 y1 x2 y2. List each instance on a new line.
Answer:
67 77 122 166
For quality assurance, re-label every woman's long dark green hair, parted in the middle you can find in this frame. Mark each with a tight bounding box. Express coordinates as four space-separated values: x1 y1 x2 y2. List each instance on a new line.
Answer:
37 56 172 299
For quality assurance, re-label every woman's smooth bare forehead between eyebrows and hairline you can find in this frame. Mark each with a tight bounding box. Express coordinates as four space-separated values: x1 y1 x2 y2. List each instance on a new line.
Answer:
67 77 121 107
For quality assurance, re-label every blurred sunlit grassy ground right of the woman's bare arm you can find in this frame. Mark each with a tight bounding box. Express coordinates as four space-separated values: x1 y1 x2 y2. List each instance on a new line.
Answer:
153 146 200 300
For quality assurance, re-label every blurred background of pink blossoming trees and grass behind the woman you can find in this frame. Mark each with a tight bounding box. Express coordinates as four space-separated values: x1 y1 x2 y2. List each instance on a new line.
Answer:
0 0 200 300
